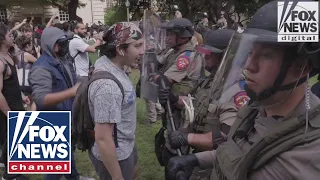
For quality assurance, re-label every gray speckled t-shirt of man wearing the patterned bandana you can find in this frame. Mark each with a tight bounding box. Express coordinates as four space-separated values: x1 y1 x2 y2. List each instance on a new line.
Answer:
88 56 136 161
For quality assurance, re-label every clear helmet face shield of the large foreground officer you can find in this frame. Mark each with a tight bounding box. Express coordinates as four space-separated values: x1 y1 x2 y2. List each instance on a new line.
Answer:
211 33 308 105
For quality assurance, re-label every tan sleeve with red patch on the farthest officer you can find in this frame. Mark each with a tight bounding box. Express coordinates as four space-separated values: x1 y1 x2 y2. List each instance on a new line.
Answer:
164 53 190 83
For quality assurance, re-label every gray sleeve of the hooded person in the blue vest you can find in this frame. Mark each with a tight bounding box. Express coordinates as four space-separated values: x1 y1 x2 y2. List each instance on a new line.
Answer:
29 68 52 107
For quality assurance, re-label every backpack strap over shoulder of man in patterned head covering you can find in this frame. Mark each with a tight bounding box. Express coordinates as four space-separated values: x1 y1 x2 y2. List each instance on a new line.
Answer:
88 71 125 147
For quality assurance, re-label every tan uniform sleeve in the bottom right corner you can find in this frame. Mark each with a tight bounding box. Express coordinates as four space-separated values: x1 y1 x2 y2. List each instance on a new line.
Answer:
250 139 320 180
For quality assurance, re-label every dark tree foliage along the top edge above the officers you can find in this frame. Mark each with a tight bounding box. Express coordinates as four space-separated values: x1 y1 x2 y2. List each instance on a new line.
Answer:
110 0 271 24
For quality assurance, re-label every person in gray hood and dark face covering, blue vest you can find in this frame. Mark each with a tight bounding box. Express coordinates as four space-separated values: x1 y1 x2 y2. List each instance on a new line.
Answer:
29 27 95 180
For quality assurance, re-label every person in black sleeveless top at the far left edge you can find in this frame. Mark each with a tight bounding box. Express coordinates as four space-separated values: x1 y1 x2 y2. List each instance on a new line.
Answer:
0 23 28 180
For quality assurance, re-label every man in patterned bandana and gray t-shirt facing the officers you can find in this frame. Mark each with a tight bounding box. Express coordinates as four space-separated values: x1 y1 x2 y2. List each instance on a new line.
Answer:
88 22 144 180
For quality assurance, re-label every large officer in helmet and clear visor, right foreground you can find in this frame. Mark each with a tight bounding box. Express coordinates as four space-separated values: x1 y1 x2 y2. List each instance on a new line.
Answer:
168 1 320 180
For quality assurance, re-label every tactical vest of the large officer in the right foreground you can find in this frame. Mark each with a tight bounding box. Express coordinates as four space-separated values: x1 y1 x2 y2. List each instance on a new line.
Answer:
211 105 320 180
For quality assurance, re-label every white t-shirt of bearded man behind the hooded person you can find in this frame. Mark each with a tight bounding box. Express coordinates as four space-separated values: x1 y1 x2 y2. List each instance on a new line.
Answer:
69 35 89 76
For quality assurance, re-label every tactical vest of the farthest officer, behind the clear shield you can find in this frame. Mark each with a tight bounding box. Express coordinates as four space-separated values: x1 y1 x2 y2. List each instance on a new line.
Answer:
159 43 197 96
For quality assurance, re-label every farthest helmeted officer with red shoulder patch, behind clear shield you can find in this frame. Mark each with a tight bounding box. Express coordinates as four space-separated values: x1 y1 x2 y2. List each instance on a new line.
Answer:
154 18 204 179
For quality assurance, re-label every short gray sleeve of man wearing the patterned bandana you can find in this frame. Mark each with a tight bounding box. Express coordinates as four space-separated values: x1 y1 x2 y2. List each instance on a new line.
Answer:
88 79 123 123
